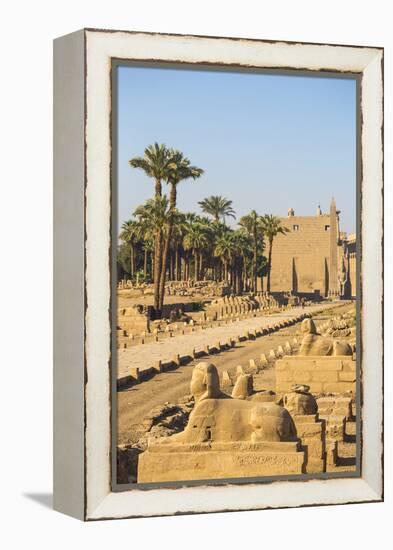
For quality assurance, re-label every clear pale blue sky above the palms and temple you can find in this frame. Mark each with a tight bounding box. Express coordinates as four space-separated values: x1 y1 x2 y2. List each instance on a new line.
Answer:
117 66 356 233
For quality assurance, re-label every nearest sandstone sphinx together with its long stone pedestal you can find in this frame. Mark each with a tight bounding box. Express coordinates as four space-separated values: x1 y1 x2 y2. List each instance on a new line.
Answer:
138 363 304 483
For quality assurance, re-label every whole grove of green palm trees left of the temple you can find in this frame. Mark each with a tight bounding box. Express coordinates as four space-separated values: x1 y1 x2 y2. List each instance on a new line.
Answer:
119 143 287 317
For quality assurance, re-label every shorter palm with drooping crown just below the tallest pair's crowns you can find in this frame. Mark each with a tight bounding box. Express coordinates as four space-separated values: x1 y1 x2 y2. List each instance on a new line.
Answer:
134 195 169 317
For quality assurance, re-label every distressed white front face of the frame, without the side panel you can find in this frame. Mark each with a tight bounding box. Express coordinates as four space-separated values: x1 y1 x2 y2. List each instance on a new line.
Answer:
72 30 383 519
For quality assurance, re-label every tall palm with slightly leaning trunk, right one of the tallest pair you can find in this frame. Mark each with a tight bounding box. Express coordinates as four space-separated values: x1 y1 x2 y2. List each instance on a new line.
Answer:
159 149 203 310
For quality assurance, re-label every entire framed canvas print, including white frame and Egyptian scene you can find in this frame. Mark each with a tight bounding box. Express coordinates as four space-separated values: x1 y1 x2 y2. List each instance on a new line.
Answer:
54 29 383 520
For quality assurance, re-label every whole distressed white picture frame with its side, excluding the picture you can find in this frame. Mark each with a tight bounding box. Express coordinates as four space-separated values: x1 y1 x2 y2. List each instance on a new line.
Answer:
54 29 383 520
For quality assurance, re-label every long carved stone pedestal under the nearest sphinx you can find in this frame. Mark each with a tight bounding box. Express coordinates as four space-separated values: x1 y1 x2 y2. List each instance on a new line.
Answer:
138 442 304 483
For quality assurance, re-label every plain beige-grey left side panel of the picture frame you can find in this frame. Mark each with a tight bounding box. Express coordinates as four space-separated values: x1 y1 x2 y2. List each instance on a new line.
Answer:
53 31 85 519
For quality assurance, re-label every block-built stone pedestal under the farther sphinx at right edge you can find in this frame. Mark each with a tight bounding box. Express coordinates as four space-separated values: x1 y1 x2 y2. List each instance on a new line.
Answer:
276 355 356 394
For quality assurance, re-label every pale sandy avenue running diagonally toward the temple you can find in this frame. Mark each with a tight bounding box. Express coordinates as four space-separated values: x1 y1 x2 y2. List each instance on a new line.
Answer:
118 303 345 380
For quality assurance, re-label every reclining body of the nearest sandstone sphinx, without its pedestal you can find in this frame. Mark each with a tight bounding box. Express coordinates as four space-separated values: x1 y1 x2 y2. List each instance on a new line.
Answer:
154 363 297 447
